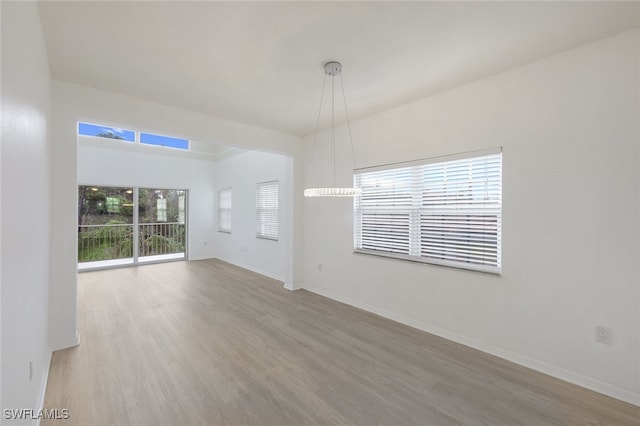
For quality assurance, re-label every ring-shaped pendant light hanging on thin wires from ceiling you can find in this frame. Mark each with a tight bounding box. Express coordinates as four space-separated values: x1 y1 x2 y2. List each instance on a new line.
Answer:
304 61 362 197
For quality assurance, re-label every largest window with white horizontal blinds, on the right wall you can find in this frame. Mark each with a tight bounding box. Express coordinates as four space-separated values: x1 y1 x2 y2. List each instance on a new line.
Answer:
354 150 502 274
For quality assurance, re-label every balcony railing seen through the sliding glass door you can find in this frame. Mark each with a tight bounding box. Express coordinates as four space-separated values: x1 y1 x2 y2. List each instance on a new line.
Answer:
78 222 185 263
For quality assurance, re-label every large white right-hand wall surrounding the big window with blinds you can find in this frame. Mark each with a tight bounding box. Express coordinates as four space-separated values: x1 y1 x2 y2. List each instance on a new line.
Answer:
304 31 640 404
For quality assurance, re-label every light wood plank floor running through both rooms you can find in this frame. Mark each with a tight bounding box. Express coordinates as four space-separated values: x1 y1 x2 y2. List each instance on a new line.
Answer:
42 260 640 426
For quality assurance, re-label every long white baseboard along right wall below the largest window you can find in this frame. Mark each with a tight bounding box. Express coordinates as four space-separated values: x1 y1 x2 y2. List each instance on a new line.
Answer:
301 284 640 407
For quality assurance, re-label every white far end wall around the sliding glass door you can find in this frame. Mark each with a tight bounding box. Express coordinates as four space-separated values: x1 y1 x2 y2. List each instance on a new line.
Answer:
78 138 215 260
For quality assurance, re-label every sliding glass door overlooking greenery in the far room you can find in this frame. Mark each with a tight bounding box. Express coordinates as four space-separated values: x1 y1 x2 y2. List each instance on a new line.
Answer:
78 185 187 269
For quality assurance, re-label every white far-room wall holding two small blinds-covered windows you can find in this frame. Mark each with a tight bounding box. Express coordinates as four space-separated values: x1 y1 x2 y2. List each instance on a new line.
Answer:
216 151 291 281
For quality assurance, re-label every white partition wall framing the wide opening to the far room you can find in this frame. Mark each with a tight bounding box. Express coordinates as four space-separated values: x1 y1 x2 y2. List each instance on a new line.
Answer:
49 80 302 349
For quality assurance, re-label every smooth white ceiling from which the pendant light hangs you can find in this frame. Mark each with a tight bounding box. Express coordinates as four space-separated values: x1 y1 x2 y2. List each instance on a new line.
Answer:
39 1 640 135
